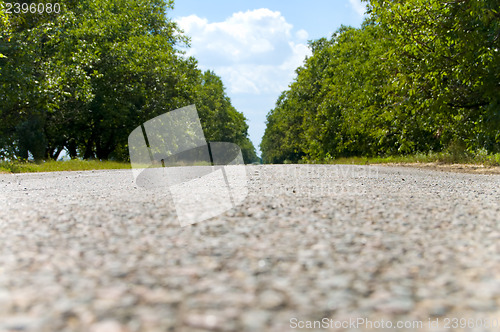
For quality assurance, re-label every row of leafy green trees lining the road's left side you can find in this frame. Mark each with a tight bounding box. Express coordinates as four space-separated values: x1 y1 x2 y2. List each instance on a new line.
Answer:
0 0 257 162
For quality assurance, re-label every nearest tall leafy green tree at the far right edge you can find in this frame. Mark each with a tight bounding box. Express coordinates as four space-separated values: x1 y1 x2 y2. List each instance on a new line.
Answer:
371 0 500 151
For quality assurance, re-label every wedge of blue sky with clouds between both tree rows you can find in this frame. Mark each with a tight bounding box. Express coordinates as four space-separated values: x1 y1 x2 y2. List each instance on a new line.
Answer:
169 0 365 155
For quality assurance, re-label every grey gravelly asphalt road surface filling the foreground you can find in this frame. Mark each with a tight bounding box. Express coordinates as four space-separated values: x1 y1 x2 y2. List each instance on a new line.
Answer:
0 165 500 332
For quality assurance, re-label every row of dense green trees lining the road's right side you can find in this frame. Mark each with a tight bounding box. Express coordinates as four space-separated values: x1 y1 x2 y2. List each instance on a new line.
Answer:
261 0 500 163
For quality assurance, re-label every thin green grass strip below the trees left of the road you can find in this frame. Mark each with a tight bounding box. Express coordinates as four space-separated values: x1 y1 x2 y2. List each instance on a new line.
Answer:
0 159 130 173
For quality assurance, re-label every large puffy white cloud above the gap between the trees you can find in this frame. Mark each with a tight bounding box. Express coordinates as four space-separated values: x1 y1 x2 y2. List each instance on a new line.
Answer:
176 8 310 94
